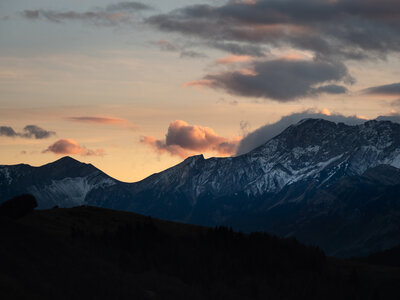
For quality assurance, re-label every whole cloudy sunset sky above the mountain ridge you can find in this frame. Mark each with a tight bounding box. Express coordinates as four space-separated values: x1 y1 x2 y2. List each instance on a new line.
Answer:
0 0 400 182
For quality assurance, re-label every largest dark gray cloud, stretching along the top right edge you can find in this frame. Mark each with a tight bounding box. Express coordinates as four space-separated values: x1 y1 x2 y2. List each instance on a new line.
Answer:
146 0 400 59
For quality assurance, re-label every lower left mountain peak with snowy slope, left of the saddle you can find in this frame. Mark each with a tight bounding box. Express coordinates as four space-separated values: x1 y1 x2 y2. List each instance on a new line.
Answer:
0 156 117 208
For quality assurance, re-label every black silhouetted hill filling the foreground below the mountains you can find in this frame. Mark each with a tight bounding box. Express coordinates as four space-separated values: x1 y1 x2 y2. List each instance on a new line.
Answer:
0 207 400 300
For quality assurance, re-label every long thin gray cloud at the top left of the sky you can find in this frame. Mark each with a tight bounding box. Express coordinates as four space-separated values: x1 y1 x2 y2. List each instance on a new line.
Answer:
22 2 152 26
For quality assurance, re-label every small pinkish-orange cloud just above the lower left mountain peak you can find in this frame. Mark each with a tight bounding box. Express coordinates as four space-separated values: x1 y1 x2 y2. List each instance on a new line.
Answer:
42 139 104 156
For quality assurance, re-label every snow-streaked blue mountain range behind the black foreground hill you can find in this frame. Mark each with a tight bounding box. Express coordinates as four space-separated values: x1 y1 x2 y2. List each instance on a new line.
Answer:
0 119 400 257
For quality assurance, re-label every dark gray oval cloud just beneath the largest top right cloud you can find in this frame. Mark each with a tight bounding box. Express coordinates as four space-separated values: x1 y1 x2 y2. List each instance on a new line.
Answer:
186 59 353 102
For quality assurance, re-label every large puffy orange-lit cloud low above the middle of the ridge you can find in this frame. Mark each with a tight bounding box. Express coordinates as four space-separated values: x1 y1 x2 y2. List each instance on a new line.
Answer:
141 120 240 158
